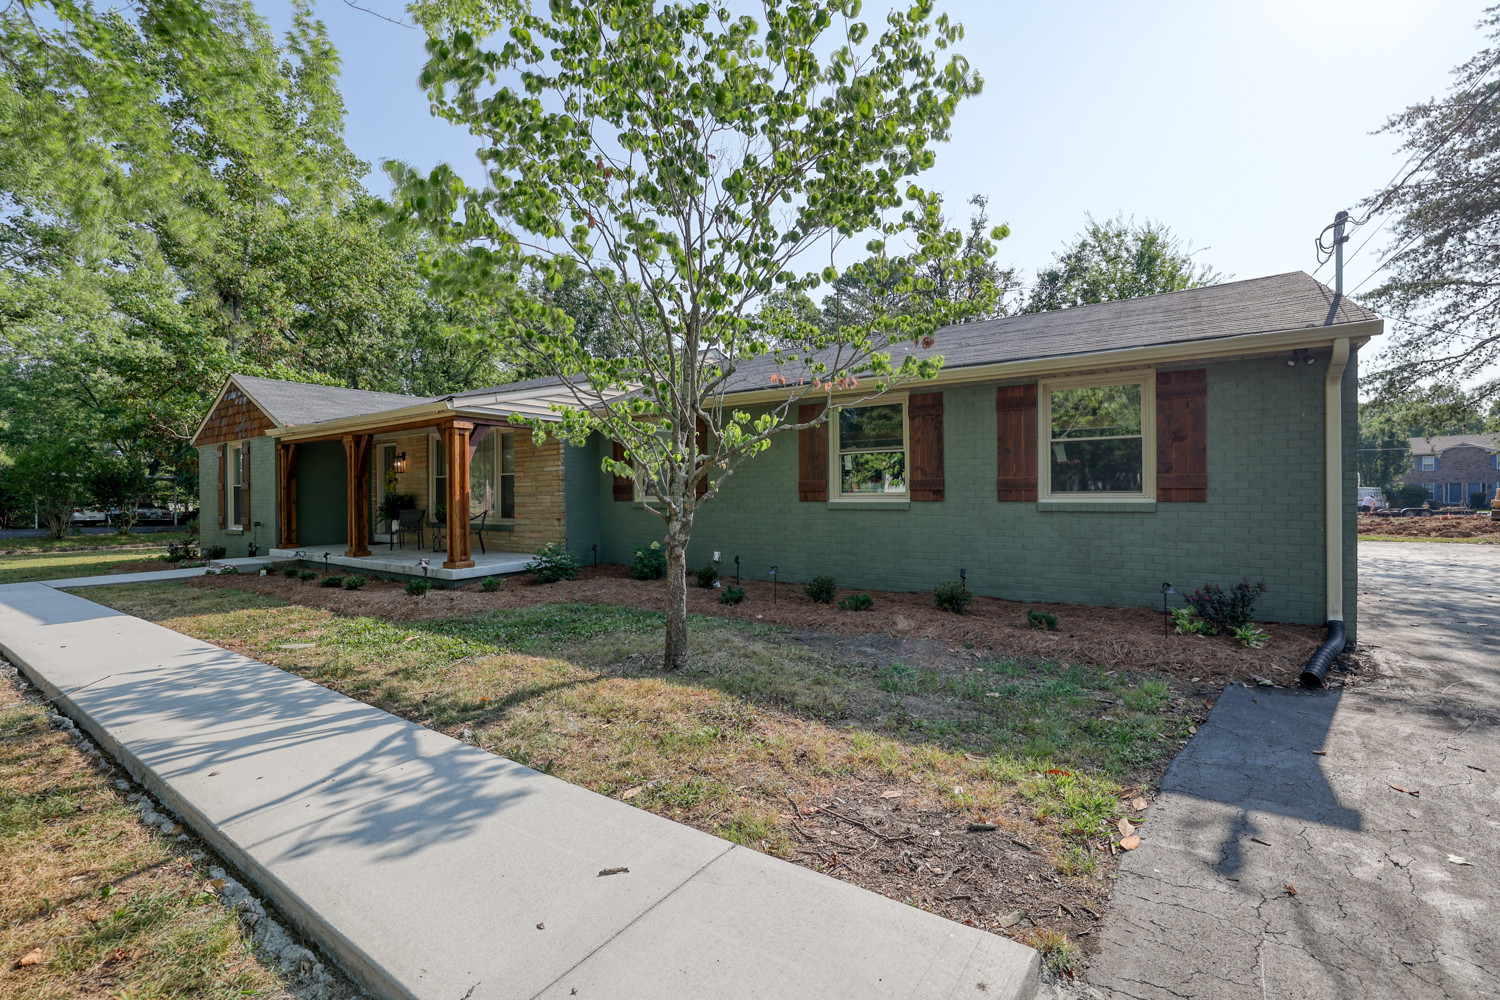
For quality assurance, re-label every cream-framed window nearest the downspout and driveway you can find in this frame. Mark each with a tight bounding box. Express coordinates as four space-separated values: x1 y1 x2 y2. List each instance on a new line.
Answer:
1038 379 1155 498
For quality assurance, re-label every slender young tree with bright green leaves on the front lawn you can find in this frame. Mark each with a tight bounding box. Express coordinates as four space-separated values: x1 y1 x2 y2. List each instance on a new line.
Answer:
389 0 993 669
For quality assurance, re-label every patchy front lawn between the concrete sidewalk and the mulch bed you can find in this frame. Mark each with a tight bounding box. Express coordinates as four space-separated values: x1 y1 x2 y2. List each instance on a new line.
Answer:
84 582 1191 876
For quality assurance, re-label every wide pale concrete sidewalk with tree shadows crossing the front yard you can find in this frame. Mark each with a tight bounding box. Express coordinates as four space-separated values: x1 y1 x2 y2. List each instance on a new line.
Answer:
0 583 1038 1000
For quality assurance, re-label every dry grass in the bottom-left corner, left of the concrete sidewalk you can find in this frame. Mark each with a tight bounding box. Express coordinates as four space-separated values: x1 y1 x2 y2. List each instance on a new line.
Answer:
0 668 291 1000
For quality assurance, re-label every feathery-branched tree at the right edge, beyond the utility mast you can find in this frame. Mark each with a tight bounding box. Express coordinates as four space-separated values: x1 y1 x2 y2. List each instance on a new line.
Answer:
1362 6 1500 423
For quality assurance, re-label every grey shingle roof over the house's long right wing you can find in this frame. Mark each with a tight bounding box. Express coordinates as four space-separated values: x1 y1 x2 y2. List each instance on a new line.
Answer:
720 271 1379 391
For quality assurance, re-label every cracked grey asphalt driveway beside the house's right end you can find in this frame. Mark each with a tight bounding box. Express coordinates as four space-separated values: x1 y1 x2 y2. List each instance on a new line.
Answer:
1083 543 1500 1000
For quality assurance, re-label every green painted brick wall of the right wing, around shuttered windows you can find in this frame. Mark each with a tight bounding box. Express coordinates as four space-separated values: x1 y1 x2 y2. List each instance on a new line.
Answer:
594 352 1358 636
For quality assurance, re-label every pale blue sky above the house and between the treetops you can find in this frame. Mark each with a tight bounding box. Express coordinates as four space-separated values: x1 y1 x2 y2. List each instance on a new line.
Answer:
260 0 1484 302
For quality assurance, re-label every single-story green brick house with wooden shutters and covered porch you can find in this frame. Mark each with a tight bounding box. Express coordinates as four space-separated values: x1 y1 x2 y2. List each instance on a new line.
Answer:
195 273 1382 636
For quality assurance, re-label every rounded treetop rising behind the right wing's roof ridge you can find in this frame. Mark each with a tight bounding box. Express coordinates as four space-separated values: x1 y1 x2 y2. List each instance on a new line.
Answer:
1025 214 1223 312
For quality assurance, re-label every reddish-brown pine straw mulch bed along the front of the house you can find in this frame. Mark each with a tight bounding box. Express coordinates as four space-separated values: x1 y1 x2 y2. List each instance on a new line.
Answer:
186 565 1323 690
